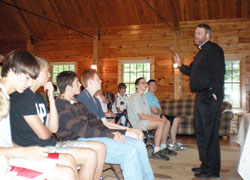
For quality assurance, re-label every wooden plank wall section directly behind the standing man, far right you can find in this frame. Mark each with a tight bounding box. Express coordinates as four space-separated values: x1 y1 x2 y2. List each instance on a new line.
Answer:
180 19 250 108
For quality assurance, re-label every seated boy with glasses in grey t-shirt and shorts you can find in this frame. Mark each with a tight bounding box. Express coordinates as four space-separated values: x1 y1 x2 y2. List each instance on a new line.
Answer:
128 77 177 160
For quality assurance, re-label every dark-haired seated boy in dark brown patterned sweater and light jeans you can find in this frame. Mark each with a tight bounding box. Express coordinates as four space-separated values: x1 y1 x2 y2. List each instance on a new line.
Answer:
56 71 154 180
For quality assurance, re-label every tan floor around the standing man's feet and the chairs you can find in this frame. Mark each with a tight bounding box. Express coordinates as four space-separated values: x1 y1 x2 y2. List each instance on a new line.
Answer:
103 134 241 180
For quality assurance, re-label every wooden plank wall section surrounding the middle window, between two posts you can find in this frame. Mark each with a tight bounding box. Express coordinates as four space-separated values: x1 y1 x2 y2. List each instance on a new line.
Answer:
100 24 176 99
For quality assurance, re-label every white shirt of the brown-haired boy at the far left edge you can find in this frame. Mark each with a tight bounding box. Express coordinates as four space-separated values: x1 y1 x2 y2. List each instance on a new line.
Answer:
0 83 12 147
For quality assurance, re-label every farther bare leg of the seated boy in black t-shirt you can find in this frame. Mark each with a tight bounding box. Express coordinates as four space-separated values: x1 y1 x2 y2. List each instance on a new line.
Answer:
88 141 106 180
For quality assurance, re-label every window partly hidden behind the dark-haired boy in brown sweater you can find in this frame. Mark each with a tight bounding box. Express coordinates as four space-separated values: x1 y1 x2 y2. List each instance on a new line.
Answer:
50 62 75 84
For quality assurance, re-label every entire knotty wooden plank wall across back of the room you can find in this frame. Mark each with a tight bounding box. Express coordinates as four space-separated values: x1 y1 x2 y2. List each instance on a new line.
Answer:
0 19 250 108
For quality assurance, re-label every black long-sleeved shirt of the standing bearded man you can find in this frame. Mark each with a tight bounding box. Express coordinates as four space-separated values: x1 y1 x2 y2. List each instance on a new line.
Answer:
180 41 225 98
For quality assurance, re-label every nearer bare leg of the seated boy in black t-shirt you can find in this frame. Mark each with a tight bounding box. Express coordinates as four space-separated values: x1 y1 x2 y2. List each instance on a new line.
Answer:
71 148 98 180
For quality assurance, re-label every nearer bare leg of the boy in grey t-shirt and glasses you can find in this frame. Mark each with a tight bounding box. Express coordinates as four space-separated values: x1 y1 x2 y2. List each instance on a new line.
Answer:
147 120 166 147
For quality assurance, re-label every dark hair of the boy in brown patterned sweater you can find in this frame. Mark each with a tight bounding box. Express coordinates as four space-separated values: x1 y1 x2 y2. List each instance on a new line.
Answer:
56 71 77 93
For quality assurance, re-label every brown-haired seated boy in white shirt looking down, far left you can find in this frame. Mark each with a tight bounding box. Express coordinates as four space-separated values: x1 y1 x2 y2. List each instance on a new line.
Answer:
0 50 76 180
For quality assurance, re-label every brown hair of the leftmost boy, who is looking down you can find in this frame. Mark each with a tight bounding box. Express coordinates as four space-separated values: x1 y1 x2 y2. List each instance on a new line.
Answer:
1 50 40 79
